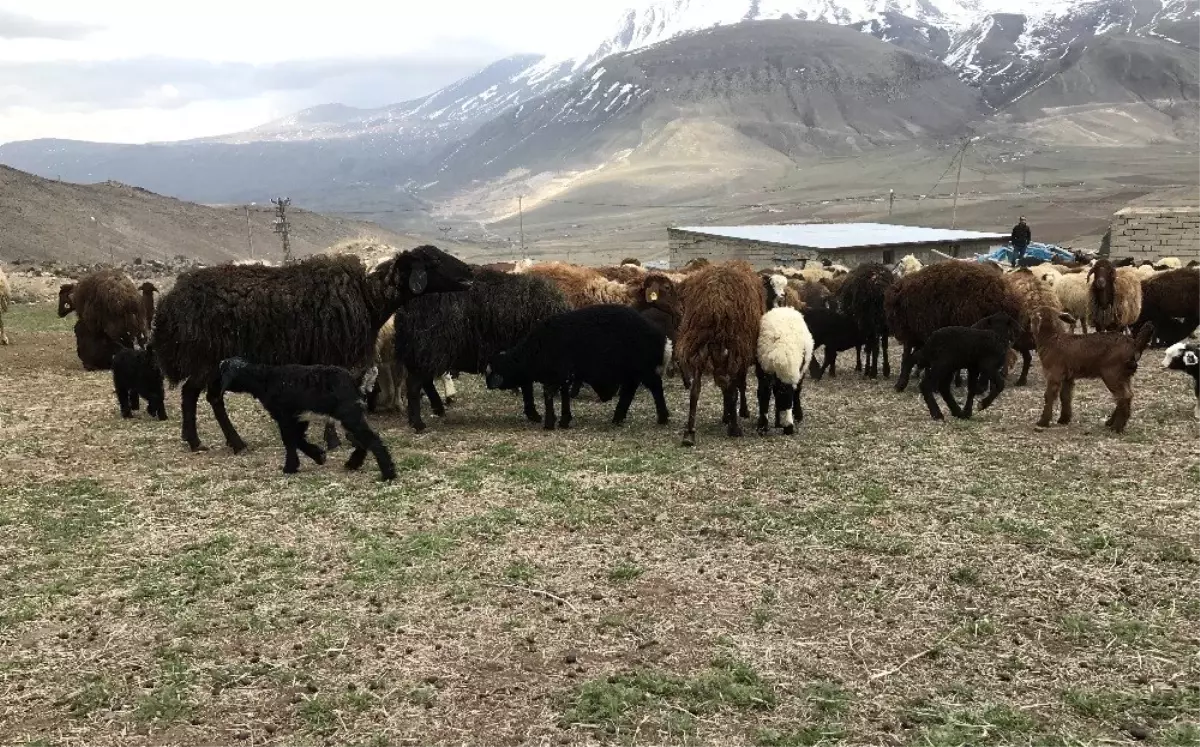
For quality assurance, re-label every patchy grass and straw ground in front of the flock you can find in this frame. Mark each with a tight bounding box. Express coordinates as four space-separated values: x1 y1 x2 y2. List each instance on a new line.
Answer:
0 306 1200 747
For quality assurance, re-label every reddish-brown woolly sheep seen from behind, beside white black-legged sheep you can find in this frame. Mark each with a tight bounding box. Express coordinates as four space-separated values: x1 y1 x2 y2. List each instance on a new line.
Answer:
676 259 767 446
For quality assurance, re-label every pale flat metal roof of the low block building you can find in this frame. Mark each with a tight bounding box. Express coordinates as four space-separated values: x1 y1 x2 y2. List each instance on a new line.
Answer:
677 223 1008 249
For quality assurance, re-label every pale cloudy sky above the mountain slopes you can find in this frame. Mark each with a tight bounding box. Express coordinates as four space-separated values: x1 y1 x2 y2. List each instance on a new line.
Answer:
0 0 635 143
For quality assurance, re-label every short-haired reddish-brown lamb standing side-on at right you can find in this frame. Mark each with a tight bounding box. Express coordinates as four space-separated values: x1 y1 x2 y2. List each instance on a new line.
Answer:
1032 309 1154 434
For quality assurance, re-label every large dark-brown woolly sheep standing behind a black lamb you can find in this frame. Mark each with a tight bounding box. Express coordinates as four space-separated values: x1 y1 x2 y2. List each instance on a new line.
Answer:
883 262 1021 392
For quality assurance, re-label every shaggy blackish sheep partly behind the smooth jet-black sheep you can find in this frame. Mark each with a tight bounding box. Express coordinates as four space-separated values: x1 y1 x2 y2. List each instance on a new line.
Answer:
395 269 570 431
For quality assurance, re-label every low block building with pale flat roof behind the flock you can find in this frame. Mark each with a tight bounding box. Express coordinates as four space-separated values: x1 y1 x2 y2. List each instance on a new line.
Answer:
667 223 1008 269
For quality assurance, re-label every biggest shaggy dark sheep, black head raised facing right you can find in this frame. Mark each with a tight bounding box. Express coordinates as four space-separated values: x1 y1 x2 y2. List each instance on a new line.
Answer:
154 246 472 452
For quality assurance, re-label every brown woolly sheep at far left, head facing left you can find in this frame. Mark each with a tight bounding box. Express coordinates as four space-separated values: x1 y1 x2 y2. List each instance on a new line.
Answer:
59 269 146 365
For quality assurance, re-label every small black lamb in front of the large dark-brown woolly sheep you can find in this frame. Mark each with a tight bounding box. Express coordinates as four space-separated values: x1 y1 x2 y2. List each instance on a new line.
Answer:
916 311 1020 420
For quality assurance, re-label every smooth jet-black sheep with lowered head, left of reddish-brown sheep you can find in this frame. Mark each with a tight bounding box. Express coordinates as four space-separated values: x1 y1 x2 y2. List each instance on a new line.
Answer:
487 305 671 430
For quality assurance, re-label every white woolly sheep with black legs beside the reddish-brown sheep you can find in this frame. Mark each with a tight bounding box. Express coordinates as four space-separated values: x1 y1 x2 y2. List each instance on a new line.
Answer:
755 306 814 436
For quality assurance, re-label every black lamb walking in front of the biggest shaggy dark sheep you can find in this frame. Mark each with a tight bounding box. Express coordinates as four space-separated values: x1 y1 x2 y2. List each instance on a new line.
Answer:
217 358 396 480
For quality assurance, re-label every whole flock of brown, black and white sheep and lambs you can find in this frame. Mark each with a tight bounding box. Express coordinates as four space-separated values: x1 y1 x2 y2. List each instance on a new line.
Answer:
7 241 1200 479
